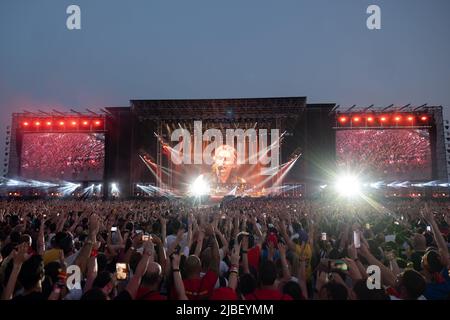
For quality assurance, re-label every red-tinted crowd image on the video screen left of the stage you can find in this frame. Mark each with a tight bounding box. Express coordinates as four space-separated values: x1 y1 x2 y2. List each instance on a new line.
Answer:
21 133 105 181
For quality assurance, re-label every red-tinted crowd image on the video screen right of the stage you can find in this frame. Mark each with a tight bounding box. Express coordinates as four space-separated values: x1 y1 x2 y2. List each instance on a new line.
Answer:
336 129 432 181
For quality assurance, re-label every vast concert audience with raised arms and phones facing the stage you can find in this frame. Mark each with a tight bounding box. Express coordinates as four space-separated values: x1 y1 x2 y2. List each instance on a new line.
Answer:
0 198 450 300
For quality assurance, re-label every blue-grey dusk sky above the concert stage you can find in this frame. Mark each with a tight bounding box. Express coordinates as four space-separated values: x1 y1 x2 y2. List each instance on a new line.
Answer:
0 0 450 168
